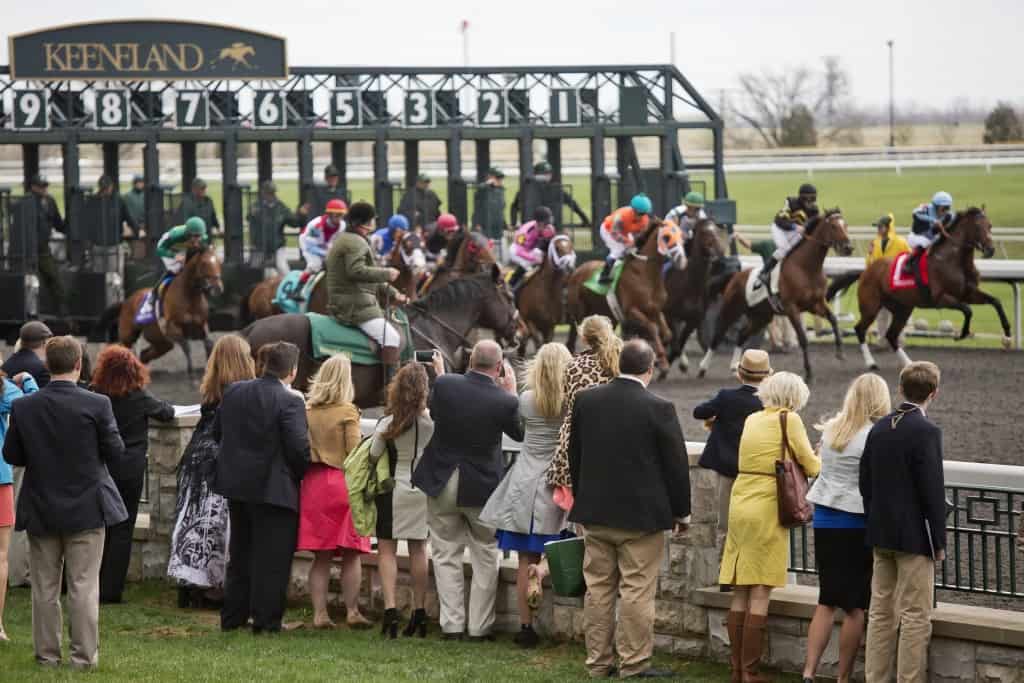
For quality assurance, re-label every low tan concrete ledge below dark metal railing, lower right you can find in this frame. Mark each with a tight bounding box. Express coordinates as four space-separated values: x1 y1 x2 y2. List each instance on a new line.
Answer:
692 586 1024 648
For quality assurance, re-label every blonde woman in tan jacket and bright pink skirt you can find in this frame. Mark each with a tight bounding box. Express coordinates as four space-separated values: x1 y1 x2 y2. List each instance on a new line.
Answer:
298 354 370 629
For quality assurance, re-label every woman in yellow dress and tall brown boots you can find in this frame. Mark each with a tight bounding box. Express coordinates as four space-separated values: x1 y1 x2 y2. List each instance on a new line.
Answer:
719 373 821 683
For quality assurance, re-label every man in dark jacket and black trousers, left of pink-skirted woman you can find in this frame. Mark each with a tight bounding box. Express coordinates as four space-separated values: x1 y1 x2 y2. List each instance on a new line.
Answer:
213 342 309 634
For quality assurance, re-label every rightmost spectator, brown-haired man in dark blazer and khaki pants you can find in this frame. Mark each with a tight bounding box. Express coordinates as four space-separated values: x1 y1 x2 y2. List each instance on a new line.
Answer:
860 361 946 683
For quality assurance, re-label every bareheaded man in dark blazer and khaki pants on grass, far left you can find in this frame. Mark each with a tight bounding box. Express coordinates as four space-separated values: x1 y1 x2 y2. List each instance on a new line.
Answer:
3 337 128 669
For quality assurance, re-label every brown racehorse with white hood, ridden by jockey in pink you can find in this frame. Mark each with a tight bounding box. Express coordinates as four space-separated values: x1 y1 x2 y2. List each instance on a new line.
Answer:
516 234 575 358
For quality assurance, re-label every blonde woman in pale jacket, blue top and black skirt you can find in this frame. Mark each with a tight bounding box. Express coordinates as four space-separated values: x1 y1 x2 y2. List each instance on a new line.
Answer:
804 373 892 683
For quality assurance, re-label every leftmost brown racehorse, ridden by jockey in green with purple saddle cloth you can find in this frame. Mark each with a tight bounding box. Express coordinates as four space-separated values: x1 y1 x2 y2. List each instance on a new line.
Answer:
99 247 224 375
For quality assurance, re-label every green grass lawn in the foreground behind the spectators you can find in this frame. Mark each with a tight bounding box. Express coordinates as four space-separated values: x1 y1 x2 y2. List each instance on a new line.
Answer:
0 582 782 683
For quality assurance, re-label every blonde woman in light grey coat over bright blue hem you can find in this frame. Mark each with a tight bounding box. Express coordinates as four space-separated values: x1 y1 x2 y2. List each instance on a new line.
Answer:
480 343 572 647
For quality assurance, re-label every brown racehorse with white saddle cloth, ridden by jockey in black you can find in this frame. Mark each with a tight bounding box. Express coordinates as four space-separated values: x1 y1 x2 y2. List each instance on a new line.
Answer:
697 208 853 382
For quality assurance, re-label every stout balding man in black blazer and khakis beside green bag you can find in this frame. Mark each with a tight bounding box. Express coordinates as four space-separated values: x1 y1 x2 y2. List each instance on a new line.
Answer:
568 339 690 678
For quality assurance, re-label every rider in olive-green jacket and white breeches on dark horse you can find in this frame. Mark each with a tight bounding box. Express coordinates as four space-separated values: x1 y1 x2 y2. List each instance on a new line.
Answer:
326 202 408 377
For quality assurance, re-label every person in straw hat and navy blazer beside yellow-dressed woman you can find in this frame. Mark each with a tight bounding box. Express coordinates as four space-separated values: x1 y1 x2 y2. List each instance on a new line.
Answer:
693 348 771 533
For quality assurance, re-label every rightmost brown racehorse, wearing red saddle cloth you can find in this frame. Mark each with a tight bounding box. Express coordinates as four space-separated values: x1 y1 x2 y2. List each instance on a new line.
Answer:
843 207 1012 370
